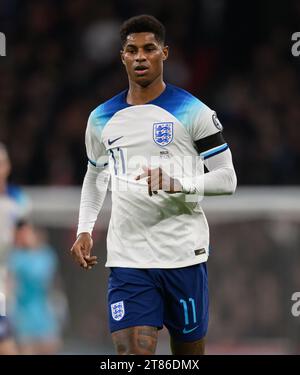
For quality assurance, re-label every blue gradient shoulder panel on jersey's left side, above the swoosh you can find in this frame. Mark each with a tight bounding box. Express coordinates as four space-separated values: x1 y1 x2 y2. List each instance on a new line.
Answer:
92 90 129 128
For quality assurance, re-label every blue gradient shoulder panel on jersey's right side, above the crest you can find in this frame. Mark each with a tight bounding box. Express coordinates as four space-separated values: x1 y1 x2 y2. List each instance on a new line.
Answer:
149 84 205 127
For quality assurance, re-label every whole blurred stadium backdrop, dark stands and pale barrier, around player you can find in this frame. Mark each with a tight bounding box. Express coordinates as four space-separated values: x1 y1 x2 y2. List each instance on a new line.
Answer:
0 0 300 353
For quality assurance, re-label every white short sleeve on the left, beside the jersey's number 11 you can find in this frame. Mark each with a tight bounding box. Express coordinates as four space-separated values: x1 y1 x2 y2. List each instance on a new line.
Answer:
85 112 108 168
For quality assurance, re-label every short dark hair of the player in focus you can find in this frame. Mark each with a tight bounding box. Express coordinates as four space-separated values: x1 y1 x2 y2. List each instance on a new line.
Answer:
120 14 166 46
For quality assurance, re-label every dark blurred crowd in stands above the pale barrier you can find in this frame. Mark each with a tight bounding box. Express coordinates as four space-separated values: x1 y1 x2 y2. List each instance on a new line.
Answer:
0 0 300 185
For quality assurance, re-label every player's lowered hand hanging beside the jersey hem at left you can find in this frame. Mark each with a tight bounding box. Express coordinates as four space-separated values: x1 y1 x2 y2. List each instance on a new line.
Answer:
71 233 98 270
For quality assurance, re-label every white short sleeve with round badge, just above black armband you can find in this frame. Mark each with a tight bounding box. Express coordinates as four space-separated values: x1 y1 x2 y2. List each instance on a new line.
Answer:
191 103 223 141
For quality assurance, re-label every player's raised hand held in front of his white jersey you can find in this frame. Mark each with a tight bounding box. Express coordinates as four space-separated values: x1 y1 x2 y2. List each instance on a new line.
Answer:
135 166 182 197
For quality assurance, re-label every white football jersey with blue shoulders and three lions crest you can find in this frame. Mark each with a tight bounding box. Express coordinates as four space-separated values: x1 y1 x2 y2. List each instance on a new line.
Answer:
86 84 221 268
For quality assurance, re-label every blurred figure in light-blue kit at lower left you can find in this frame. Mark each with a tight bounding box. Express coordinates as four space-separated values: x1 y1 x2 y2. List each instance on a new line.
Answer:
8 221 60 354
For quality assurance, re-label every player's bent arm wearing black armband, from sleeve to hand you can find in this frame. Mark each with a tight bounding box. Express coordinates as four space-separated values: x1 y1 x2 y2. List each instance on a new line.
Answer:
136 106 237 196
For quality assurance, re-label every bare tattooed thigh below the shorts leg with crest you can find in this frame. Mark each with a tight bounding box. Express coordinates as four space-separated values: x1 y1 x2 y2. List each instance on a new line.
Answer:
112 326 157 355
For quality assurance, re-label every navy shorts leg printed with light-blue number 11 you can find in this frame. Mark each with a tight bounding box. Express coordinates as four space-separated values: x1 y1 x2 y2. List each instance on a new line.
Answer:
164 263 209 347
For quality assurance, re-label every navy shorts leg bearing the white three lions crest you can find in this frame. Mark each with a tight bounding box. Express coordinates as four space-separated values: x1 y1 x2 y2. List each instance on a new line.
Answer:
108 267 163 333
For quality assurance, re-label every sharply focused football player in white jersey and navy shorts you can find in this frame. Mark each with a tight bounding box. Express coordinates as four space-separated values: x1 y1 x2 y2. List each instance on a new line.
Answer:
71 15 237 355
